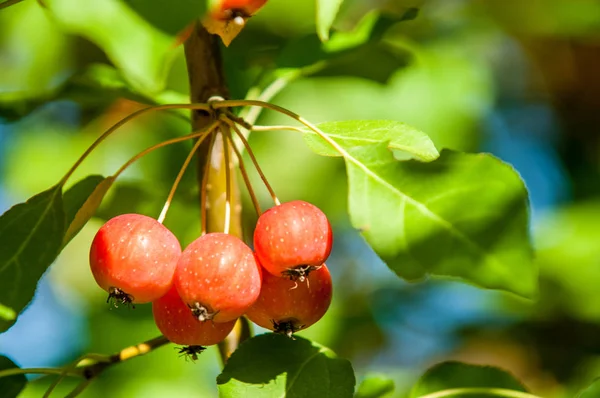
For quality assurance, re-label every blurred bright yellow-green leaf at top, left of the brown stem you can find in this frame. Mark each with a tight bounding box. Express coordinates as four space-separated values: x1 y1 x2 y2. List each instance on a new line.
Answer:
45 0 175 95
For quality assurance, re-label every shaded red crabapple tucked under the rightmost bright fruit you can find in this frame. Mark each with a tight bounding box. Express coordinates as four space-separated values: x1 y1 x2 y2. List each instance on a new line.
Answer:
246 264 333 332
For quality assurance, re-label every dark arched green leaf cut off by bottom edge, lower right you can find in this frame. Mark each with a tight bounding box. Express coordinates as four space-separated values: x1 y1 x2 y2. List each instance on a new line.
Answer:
410 361 527 398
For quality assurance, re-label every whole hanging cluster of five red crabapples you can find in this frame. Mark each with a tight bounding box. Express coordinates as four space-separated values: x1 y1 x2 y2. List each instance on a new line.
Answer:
90 200 332 355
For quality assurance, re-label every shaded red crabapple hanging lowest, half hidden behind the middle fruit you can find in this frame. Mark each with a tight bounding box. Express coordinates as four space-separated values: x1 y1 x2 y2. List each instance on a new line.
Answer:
152 286 236 346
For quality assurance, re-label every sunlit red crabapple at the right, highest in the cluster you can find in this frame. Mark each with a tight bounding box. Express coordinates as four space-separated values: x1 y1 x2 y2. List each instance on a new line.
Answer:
254 200 333 276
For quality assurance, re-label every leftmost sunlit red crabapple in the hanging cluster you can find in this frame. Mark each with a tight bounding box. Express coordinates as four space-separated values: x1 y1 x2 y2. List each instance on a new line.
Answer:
90 214 181 303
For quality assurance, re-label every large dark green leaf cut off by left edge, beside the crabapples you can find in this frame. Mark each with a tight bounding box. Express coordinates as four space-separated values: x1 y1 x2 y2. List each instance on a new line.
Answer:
0 185 65 331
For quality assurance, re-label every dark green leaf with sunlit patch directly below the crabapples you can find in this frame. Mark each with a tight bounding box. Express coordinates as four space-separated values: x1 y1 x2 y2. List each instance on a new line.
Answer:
217 333 355 398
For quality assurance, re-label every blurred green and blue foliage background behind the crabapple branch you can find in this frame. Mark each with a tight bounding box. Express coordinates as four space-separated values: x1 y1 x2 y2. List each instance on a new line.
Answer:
0 0 600 398
